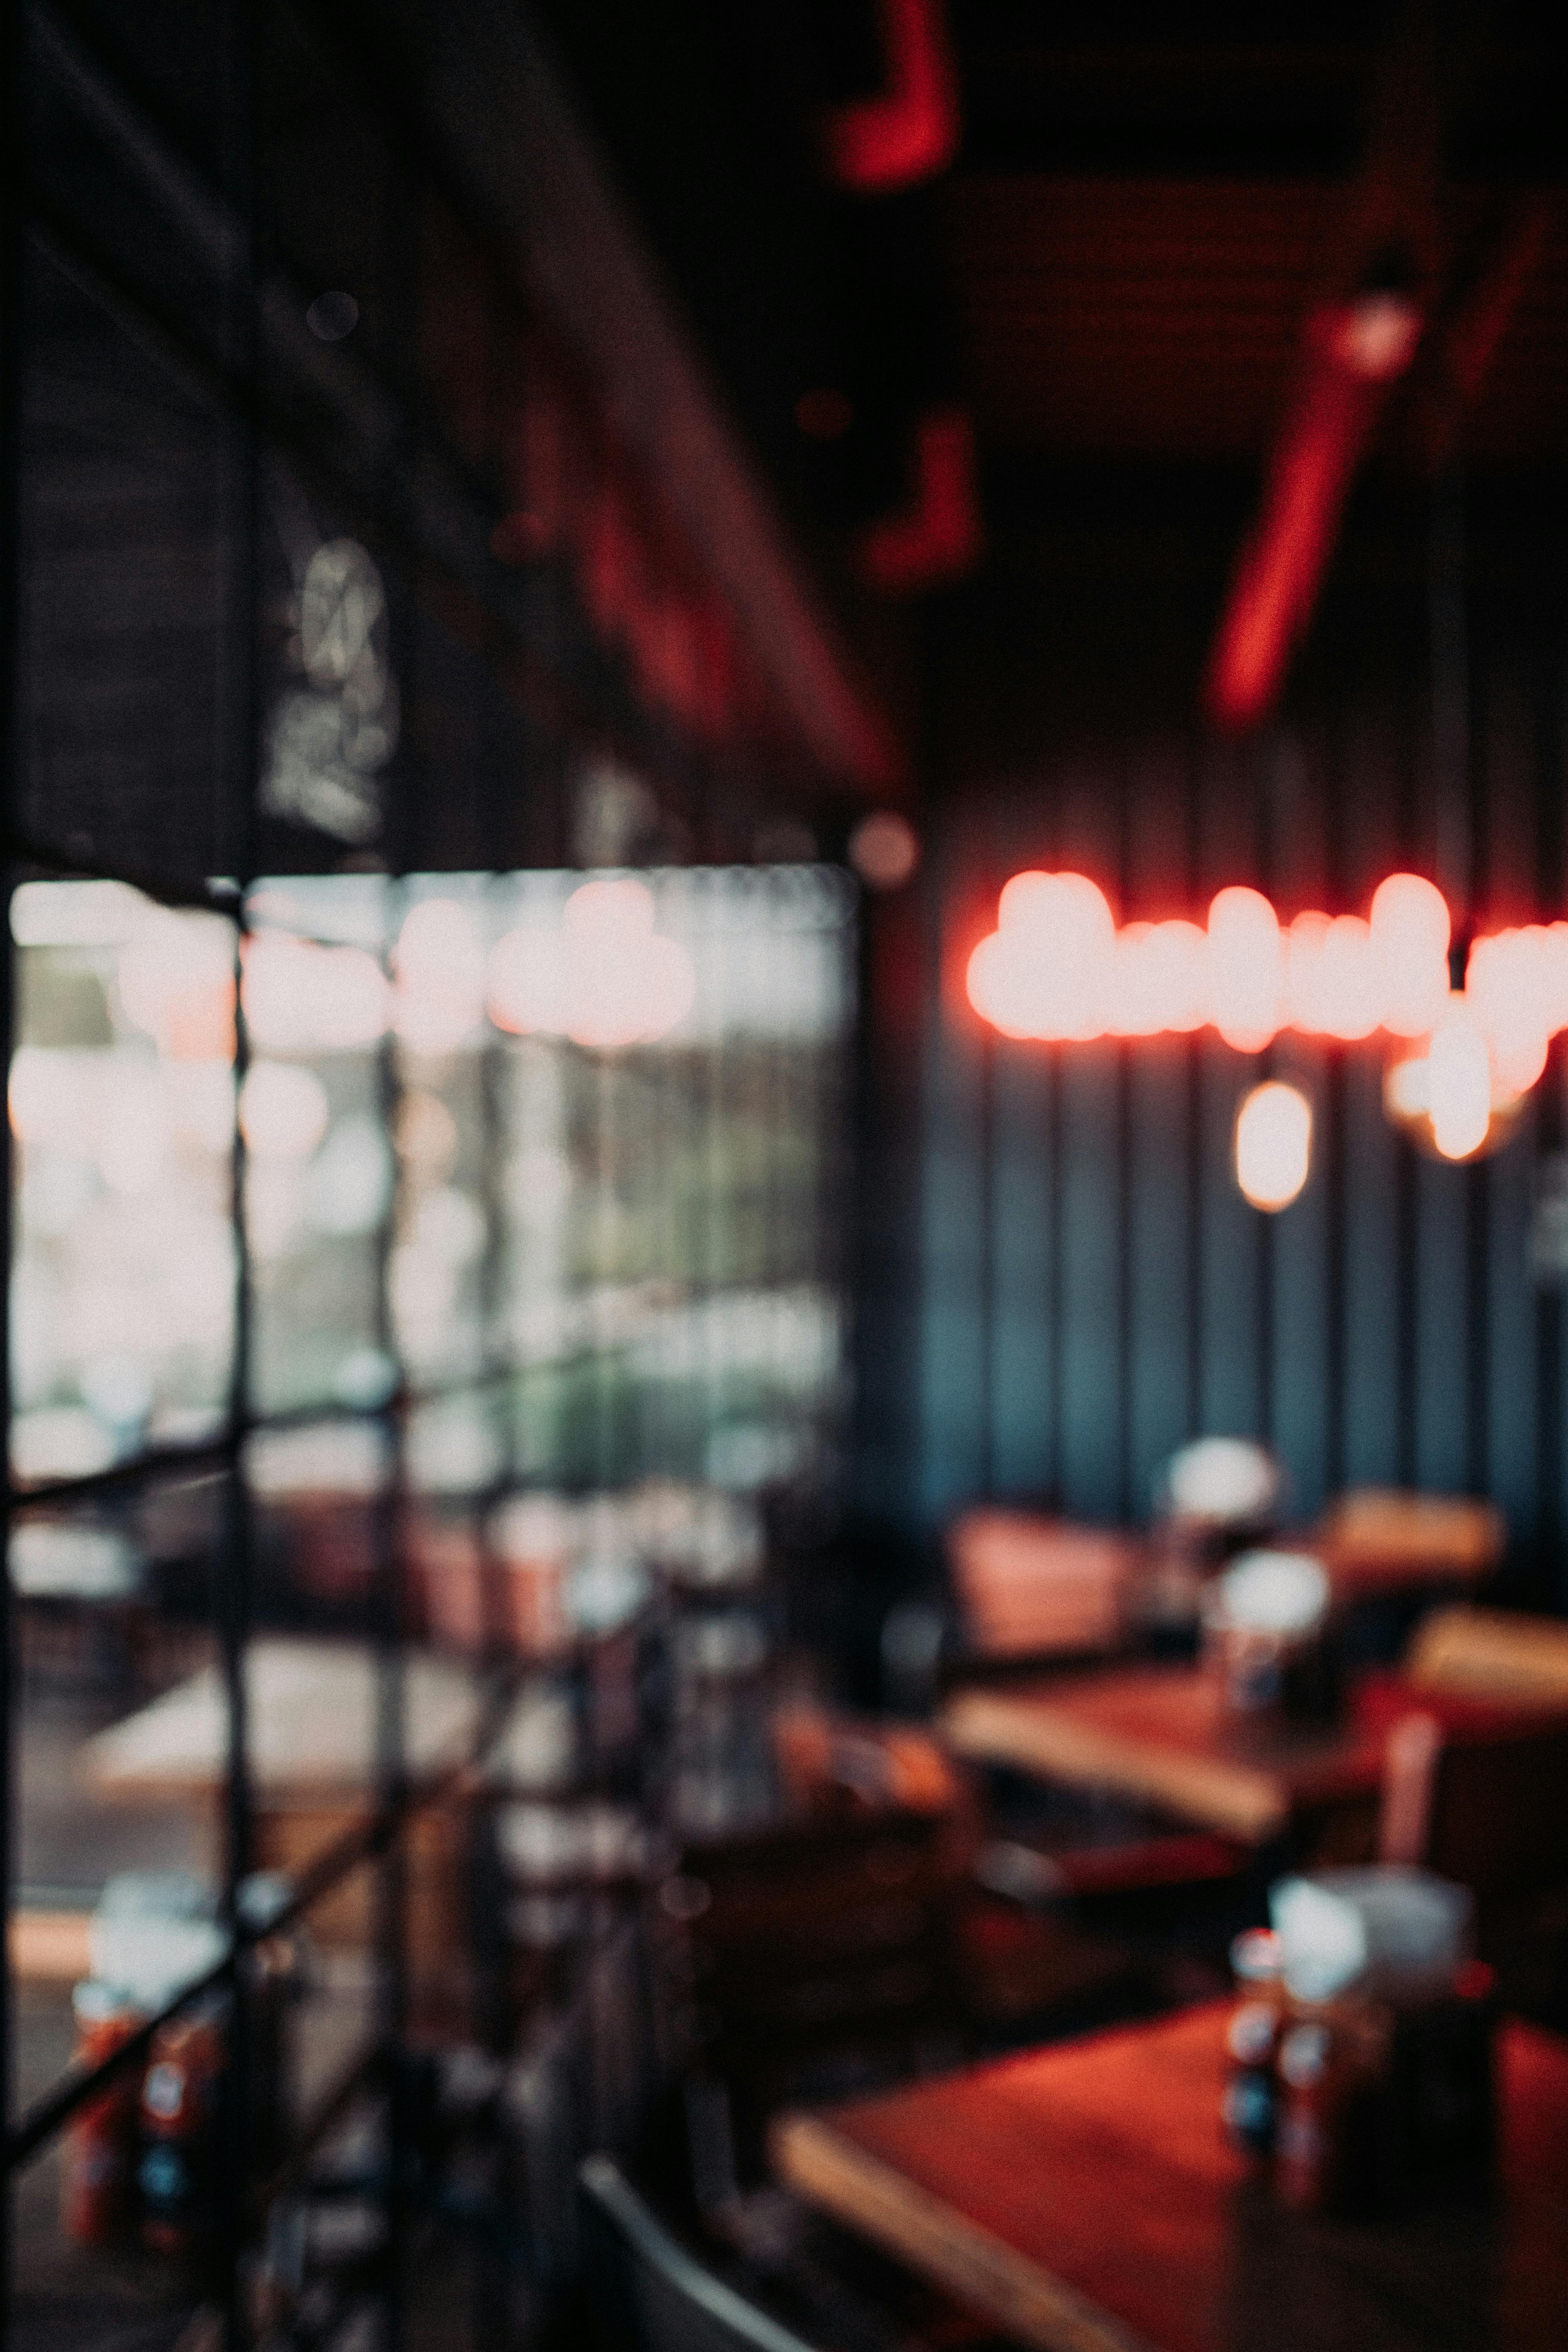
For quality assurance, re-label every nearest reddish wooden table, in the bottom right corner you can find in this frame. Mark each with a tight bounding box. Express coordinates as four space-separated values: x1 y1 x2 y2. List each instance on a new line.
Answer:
771 2004 1568 2352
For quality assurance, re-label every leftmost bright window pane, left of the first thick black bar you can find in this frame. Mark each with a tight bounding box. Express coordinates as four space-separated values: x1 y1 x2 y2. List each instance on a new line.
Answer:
9 882 235 1479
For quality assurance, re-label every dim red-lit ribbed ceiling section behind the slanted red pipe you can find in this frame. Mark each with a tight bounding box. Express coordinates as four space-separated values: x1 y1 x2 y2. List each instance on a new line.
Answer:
940 169 1568 466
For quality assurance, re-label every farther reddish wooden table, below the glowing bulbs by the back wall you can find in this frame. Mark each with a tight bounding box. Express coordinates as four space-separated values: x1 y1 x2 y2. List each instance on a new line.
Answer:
940 1665 1561 1844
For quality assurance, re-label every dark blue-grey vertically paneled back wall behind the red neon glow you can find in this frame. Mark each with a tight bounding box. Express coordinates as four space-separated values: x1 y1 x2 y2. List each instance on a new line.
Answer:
861 468 1568 1597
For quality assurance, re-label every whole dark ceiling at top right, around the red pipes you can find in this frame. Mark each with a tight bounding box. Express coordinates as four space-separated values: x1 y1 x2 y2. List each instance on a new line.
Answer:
533 0 1568 534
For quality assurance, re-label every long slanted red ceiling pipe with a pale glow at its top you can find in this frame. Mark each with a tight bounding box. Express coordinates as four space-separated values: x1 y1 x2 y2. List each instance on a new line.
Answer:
1204 294 1420 729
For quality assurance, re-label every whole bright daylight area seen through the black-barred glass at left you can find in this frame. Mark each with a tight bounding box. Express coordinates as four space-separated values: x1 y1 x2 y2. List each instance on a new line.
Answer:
9 868 853 1487
